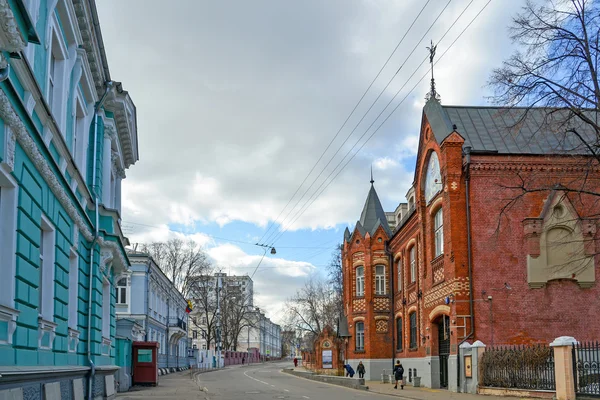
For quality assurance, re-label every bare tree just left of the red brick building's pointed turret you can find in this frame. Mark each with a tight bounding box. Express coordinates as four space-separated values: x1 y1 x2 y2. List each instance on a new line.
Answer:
286 276 339 335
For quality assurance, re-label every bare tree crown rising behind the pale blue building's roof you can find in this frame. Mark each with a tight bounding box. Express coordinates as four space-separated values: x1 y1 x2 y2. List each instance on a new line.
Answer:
141 238 211 298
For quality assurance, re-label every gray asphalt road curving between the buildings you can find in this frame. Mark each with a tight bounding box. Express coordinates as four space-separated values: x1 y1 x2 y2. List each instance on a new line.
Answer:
200 362 390 400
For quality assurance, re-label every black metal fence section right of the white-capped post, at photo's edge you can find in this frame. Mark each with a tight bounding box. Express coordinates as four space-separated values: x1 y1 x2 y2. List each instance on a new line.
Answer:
573 342 600 397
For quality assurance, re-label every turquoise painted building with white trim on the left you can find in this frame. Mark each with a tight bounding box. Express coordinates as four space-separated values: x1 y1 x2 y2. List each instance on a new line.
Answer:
0 0 138 400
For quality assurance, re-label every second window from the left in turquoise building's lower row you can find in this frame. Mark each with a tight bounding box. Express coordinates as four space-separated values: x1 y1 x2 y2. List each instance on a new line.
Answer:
38 217 55 322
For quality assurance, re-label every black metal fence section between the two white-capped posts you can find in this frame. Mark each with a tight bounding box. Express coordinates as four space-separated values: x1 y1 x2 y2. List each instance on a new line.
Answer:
480 345 556 390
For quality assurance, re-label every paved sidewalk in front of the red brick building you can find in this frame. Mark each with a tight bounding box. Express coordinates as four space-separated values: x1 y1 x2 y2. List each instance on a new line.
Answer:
365 381 517 400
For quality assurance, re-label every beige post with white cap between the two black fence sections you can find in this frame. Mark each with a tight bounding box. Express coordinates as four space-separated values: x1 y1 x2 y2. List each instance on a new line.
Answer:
550 336 577 400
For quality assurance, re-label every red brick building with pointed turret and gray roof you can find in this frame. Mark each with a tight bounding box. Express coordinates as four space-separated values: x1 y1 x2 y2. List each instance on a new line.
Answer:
342 99 600 389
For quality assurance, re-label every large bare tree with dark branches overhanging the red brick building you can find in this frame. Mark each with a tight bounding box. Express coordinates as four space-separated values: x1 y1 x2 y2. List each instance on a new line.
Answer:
489 0 600 274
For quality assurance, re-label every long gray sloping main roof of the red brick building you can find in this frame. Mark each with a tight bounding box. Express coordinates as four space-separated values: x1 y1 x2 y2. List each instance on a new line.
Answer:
424 99 596 155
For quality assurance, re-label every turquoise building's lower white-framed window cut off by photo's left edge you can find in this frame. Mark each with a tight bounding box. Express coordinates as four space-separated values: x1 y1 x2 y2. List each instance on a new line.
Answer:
0 168 19 345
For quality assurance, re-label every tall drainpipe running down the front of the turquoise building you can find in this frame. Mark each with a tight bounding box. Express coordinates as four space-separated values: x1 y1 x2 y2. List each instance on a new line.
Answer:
87 81 113 400
